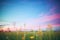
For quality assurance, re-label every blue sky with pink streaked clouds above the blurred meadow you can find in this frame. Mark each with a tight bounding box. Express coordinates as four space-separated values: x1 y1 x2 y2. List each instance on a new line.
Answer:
0 0 60 29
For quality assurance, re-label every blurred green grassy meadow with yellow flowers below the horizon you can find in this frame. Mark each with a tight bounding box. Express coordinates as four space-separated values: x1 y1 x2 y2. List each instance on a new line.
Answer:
0 31 60 40
